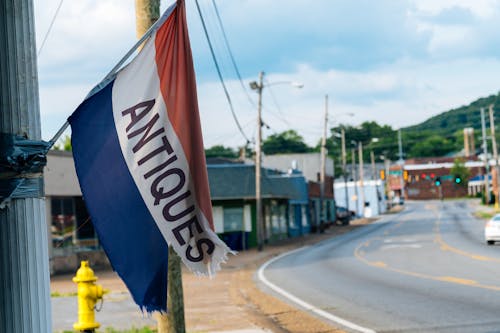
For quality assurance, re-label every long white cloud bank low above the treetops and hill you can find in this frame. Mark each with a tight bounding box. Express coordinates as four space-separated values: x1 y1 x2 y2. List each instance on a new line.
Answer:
195 59 500 146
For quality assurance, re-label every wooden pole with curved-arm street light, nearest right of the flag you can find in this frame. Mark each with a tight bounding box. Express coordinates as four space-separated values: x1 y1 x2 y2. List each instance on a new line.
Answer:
250 72 304 251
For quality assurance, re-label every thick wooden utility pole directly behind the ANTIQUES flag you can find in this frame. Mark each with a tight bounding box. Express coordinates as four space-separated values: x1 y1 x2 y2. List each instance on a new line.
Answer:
135 0 186 333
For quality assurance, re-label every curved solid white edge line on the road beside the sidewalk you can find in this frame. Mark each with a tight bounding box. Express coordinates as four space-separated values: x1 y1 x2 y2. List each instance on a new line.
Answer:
257 247 376 333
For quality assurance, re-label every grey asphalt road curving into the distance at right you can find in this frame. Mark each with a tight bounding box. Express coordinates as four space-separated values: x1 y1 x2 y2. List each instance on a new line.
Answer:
261 201 500 333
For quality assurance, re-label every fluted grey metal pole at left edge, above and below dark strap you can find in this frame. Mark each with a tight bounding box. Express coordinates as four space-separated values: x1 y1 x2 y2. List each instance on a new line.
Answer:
0 0 52 333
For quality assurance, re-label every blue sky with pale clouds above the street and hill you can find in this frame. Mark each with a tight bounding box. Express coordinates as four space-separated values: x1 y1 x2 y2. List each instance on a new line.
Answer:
34 0 500 148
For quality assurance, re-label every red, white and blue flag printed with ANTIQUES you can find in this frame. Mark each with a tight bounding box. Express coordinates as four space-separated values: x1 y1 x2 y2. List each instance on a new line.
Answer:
68 1 230 312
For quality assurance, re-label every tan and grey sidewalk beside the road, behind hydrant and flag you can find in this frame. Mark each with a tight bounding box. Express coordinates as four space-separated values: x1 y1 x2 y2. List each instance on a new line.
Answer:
51 219 370 333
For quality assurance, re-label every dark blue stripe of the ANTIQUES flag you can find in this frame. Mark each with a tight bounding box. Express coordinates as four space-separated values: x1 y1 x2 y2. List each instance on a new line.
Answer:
68 81 168 312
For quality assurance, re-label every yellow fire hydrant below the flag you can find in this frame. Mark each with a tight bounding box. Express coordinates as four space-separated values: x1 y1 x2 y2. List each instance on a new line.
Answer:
73 261 104 332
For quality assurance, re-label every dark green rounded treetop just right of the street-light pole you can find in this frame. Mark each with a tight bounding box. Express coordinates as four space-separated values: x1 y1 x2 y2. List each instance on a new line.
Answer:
262 130 312 155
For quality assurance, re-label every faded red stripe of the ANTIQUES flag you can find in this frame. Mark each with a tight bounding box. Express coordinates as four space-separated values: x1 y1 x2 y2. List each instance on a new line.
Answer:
155 0 214 230
